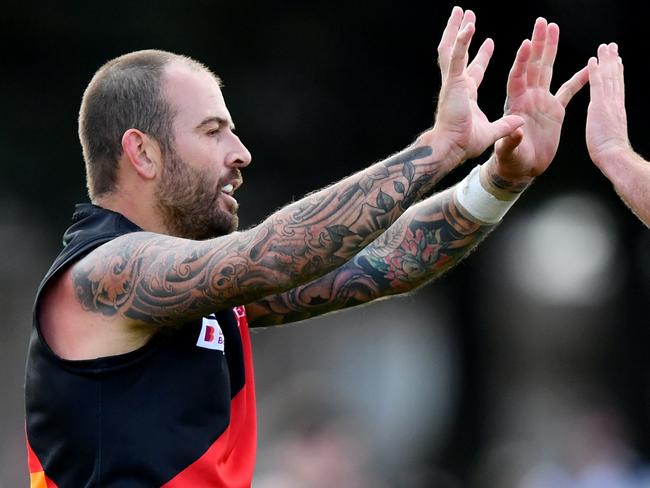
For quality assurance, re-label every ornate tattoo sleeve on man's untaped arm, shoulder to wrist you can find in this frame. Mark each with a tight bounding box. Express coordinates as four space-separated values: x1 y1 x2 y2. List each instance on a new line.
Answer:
72 146 451 325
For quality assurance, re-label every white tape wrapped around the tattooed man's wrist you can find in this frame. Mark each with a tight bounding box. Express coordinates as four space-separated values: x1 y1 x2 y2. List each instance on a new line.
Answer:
455 164 519 224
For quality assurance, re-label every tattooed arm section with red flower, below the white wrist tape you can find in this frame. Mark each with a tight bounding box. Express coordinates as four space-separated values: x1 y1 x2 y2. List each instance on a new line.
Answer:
246 189 495 326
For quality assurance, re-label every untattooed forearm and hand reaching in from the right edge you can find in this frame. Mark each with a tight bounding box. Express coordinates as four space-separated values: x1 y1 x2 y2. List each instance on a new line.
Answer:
586 43 650 227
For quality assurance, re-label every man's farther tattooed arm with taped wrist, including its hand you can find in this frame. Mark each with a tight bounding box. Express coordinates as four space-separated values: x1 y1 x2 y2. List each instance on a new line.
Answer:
247 19 587 326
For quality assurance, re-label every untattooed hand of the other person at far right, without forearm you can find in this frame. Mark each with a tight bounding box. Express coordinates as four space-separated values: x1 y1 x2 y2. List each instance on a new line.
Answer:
587 43 632 167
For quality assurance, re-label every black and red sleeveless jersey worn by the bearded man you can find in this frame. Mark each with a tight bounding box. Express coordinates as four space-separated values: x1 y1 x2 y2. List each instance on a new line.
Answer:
25 204 256 488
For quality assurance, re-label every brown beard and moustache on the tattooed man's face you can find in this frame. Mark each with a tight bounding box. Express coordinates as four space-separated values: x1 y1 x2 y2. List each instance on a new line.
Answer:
156 149 241 240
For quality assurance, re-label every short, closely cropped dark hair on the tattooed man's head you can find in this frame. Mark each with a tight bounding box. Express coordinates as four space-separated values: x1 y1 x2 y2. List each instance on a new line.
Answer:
79 49 219 200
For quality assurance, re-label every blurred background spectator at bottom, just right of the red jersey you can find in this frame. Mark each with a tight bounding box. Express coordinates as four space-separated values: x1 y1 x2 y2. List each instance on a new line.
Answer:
253 374 387 488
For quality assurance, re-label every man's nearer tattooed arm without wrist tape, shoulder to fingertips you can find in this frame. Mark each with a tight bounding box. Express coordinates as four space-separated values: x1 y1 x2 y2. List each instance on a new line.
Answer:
72 7 522 324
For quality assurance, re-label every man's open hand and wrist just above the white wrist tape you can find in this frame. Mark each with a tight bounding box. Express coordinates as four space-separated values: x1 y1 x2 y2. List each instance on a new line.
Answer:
488 17 589 190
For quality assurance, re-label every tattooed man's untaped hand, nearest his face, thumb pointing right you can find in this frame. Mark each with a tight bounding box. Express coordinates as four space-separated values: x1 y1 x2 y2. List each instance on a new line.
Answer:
432 7 524 162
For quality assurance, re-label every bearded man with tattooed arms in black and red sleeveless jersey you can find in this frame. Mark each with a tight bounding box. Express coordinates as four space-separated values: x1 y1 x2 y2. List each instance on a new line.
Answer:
26 7 587 488
